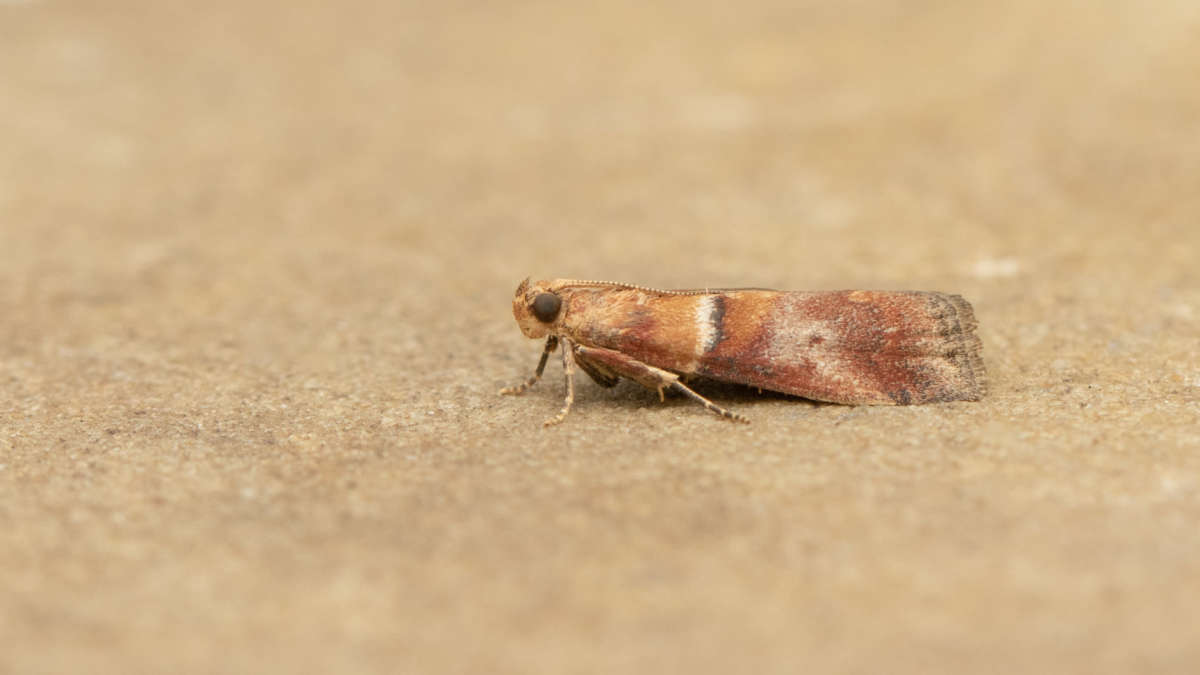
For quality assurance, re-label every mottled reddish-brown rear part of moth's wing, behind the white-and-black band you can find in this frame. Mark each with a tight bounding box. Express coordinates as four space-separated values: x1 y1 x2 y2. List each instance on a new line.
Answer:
697 291 985 405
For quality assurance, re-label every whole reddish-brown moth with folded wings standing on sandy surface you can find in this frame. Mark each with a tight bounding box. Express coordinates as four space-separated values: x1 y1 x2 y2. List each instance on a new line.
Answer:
500 279 986 426
